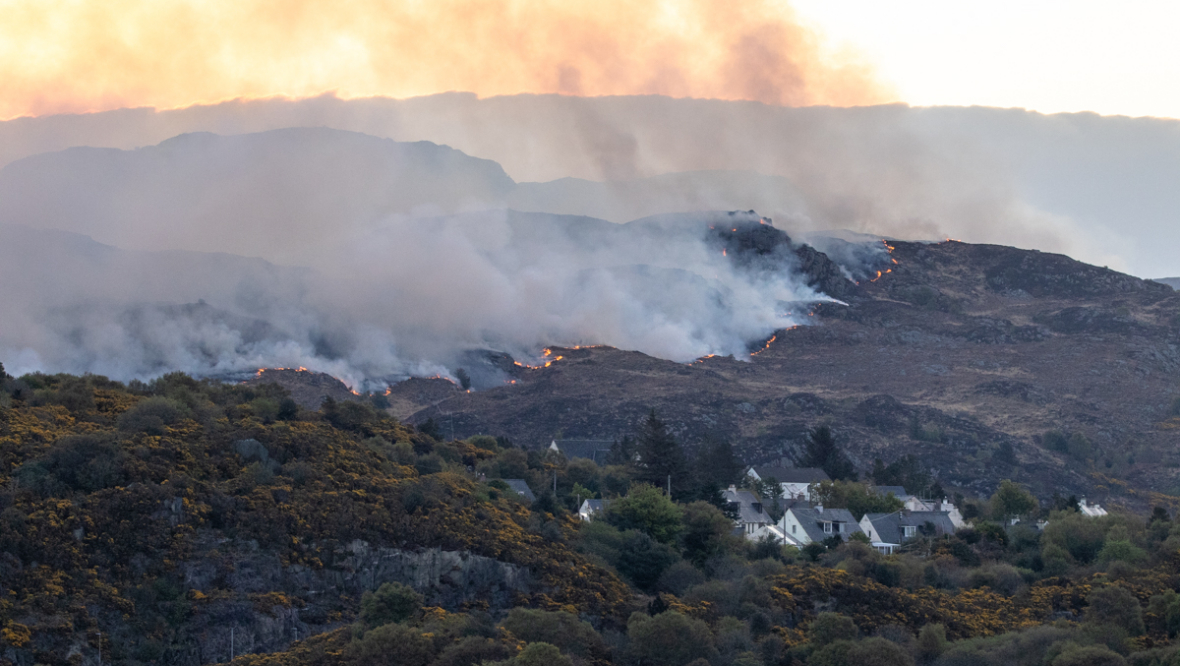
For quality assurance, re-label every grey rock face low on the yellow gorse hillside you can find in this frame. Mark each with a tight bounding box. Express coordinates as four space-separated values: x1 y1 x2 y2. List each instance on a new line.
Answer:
169 541 533 666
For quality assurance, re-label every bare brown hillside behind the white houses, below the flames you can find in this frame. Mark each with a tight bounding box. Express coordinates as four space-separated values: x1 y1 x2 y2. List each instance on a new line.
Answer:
379 239 1180 504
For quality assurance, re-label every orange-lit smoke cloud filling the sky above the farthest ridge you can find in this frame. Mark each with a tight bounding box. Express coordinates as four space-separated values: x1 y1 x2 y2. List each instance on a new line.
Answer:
0 0 893 118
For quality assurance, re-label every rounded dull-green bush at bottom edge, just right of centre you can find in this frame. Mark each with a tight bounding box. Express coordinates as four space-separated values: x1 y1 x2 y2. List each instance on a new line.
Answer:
627 611 717 666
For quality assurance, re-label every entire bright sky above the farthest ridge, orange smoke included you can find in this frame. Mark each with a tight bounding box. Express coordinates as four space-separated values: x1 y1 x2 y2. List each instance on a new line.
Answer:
0 0 1180 118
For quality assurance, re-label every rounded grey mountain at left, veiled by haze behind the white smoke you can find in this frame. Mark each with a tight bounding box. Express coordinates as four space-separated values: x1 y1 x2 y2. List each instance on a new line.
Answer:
0 129 513 263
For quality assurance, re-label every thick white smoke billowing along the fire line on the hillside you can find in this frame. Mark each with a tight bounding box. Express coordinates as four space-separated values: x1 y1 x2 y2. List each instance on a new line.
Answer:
0 205 825 389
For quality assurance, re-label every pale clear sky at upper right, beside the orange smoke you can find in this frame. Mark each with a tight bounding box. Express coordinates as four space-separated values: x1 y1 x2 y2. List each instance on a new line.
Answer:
793 0 1180 118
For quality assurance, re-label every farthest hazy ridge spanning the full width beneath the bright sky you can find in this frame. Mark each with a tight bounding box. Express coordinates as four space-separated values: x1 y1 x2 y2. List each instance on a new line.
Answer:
0 93 1180 275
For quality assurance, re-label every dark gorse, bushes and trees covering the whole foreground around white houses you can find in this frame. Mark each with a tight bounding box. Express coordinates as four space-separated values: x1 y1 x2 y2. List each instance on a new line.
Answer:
0 367 1180 666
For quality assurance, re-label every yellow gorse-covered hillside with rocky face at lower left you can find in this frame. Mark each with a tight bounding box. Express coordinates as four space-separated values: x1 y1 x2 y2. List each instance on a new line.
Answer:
0 368 630 665
